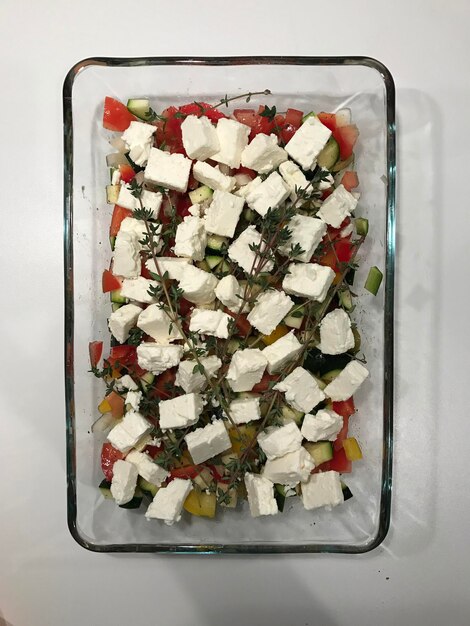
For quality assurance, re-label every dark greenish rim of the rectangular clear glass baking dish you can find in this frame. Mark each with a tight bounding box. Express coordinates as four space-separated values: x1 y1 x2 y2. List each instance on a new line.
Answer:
62 56 396 555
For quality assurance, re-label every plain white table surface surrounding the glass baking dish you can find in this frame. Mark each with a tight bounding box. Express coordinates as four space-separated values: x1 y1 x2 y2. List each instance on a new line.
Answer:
0 0 470 626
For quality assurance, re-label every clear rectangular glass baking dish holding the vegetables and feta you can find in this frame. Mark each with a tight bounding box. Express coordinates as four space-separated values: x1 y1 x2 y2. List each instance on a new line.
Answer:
63 57 395 554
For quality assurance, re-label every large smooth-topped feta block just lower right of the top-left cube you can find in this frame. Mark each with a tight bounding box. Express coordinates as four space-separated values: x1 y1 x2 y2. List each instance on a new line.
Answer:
144 148 192 193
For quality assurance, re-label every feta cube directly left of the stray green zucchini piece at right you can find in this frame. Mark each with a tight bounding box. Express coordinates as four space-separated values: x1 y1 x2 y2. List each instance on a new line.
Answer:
282 263 336 302
